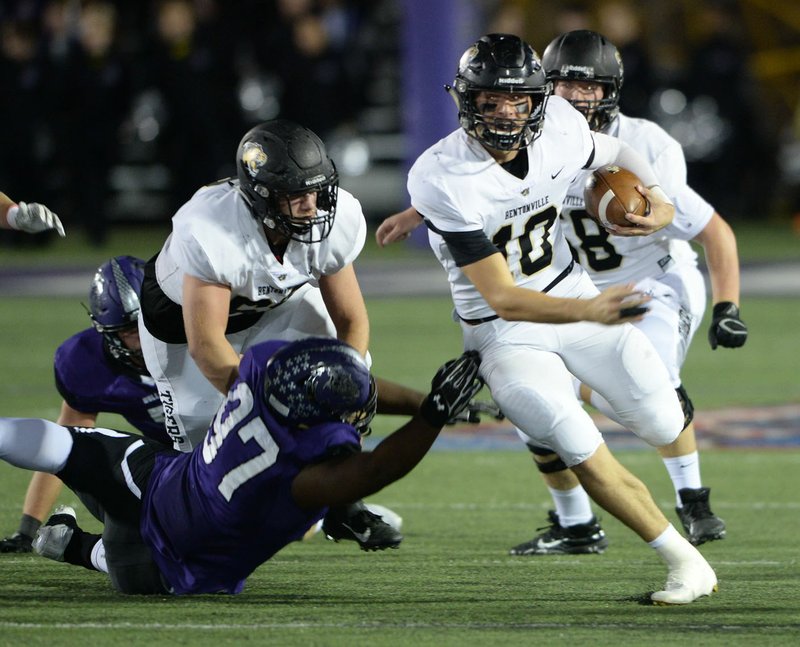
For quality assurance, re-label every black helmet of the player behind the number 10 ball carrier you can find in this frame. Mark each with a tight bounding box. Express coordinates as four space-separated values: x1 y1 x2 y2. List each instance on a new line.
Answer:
542 29 624 132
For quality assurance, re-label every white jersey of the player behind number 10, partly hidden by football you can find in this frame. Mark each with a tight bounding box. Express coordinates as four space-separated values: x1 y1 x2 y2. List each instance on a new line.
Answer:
561 115 714 290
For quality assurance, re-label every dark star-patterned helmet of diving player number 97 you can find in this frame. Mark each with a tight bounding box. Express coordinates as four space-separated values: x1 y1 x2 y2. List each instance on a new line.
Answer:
264 337 378 436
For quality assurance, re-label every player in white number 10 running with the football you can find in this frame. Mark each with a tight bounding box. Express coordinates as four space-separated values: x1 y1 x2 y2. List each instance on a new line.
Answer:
386 34 717 604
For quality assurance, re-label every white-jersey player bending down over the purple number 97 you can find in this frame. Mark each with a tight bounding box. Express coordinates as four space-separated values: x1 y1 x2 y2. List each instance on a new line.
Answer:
139 120 406 550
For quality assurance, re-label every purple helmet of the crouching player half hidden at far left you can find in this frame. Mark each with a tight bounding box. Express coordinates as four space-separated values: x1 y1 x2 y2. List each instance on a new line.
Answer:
87 256 147 374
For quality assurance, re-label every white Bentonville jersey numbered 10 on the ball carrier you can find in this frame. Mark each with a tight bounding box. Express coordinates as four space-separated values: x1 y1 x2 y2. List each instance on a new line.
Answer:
408 97 594 319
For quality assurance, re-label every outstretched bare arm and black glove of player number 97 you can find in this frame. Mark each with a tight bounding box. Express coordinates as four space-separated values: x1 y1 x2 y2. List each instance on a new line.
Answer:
292 351 483 508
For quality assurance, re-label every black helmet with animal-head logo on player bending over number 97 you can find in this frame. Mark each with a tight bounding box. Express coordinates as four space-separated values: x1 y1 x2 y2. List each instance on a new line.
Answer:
236 119 339 243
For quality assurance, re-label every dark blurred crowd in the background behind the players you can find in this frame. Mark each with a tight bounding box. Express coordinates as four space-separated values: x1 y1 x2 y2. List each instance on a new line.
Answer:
0 0 800 246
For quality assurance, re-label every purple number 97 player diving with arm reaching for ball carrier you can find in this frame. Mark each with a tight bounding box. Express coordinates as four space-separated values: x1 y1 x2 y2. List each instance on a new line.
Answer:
0 337 482 594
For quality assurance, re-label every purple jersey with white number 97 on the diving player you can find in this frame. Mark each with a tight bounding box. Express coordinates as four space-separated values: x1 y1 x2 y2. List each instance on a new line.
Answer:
141 342 360 594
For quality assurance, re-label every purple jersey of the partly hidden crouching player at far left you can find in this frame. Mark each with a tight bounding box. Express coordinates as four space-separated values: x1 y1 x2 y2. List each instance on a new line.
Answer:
54 328 172 445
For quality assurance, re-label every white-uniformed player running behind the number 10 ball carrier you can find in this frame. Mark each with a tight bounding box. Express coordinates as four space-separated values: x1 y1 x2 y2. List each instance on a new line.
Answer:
504 30 747 555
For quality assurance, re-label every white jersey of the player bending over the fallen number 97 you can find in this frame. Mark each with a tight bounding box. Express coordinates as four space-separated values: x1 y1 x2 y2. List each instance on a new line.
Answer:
156 181 367 309
